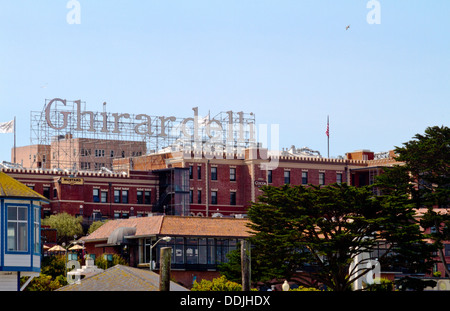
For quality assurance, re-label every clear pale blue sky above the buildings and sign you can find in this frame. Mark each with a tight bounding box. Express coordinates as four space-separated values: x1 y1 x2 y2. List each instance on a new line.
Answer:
0 0 450 161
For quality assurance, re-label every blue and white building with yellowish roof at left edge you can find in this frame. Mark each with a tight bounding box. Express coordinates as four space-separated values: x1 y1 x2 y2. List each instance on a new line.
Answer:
0 172 48 291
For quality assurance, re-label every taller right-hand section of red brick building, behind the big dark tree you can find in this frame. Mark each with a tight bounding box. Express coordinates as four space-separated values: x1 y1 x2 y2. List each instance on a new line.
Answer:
113 149 386 217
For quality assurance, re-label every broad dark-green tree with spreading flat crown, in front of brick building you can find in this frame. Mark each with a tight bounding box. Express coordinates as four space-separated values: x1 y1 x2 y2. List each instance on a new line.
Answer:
248 184 431 291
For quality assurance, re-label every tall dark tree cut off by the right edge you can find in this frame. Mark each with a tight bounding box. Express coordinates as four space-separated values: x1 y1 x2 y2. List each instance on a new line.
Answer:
376 126 450 276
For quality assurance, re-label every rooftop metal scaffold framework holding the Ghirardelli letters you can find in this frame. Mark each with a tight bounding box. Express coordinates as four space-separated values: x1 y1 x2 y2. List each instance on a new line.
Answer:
30 98 256 170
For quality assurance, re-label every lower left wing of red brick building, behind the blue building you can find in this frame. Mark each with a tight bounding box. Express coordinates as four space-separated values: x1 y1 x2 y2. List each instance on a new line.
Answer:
2 168 159 221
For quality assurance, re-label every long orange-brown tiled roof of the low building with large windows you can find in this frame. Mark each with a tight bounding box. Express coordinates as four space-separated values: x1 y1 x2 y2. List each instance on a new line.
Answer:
82 216 251 242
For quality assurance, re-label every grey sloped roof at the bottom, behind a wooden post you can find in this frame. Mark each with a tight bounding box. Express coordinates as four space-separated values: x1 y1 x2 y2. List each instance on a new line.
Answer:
58 265 188 291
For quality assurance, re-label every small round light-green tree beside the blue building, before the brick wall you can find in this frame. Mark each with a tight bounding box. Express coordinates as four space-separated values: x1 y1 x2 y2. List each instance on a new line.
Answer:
42 213 83 243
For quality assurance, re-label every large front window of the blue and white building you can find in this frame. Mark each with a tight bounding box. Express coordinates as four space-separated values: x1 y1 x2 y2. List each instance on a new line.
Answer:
7 206 28 252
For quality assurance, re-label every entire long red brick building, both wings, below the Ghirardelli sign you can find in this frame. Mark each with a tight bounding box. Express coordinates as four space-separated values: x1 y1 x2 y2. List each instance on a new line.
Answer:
2 148 393 222
